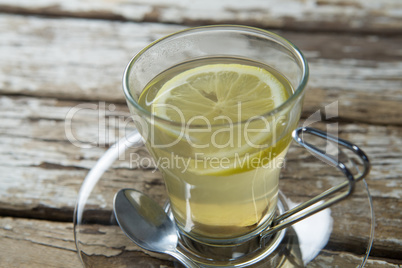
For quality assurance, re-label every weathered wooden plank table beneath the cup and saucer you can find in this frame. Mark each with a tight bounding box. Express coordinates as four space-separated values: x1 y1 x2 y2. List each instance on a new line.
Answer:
0 0 402 268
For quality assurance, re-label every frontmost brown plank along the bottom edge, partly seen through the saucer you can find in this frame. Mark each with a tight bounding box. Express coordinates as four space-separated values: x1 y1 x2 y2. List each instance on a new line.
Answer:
0 217 400 268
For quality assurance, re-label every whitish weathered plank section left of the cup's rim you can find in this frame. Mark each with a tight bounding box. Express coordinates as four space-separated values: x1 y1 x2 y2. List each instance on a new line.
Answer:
0 15 183 102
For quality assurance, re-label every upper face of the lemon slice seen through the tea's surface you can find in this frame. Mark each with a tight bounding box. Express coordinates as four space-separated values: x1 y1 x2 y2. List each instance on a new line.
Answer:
152 64 288 125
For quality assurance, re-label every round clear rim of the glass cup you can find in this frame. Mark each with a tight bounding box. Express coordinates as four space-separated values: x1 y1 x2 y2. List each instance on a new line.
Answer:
123 24 309 127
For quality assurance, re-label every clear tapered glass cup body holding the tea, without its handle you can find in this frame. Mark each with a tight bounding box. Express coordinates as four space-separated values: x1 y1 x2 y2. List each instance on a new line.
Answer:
123 25 308 246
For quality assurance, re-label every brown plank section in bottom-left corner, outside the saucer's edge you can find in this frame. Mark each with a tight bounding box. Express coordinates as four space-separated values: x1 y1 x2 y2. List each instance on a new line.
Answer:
0 217 81 268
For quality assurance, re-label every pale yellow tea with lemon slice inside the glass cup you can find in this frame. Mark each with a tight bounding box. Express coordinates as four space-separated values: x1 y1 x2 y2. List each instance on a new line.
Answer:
138 57 294 240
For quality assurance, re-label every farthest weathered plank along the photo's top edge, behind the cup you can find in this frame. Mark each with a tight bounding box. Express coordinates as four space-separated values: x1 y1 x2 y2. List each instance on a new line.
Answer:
0 0 402 33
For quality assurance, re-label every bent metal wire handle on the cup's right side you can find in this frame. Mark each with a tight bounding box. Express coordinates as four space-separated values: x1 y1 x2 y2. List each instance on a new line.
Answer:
260 127 370 241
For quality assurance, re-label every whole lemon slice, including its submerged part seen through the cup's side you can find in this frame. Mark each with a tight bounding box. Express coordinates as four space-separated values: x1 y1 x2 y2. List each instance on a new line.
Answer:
151 64 289 176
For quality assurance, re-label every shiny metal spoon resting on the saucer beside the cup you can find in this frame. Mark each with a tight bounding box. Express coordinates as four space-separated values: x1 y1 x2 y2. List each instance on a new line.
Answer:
113 189 199 268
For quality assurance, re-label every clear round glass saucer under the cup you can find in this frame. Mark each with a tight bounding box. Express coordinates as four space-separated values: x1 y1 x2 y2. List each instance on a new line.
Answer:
74 132 374 268
